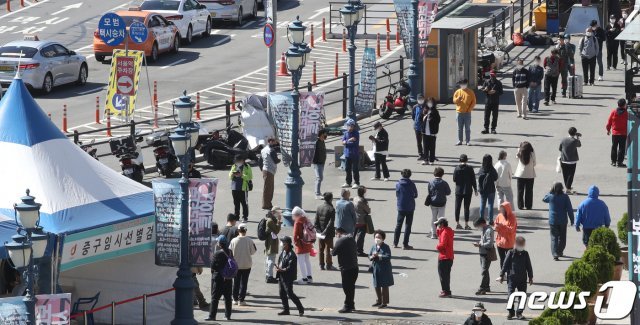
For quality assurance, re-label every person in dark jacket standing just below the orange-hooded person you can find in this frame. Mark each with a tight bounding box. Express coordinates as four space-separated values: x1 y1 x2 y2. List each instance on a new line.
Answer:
500 236 533 320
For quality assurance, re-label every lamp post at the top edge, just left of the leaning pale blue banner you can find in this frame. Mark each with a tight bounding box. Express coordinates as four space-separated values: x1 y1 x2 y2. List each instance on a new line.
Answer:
340 0 365 121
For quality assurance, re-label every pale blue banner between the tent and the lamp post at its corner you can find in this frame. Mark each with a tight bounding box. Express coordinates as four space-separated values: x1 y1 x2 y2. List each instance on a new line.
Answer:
151 179 182 266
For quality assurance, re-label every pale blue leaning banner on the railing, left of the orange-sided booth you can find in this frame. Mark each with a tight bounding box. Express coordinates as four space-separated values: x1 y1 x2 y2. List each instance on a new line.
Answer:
354 47 377 115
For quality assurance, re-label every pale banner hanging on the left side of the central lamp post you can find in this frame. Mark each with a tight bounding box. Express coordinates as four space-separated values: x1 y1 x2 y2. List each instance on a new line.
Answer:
267 92 293 166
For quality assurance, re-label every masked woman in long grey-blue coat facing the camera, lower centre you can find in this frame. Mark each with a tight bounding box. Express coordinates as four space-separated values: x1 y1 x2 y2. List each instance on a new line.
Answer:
369 229 393 309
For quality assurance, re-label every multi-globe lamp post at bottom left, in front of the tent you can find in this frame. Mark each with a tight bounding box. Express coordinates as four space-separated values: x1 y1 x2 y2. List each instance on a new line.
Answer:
5 189 49 325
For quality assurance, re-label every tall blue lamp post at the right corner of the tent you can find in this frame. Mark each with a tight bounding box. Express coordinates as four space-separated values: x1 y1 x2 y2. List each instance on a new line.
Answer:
169 91 198 325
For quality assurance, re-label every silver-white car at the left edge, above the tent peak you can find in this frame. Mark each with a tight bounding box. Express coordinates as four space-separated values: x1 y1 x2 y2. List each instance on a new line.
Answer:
0 35 89 94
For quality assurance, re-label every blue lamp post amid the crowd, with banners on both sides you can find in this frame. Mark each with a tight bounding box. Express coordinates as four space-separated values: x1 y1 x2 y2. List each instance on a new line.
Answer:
283 17 311 226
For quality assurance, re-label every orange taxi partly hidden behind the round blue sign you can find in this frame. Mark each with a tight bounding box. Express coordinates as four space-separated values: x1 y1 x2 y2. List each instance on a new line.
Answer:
93 7 180 62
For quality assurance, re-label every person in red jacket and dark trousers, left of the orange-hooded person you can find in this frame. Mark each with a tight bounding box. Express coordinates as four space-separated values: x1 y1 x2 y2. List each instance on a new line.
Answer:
434 217 453 298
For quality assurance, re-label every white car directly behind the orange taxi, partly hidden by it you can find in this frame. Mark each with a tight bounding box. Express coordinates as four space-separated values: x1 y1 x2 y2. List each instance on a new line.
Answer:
140 0 211 44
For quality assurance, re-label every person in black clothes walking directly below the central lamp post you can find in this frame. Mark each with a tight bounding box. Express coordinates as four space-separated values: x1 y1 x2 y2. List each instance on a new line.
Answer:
276 236 304 316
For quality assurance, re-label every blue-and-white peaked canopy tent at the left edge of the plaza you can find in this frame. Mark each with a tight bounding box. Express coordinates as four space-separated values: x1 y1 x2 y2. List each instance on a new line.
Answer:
0 77 176 324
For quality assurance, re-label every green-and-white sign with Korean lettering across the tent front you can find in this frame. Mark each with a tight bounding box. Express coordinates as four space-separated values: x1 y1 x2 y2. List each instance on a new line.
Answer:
60 216 154 272
